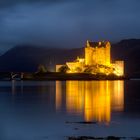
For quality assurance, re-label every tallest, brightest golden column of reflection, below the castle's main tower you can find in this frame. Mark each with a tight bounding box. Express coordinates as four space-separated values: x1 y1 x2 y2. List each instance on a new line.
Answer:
84 81 110 122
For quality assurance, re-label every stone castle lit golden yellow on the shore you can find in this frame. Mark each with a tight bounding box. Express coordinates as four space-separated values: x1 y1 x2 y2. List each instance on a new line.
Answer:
56 41 124 76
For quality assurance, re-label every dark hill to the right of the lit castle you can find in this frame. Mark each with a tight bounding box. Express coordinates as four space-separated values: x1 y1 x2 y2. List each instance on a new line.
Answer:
112 39 140 75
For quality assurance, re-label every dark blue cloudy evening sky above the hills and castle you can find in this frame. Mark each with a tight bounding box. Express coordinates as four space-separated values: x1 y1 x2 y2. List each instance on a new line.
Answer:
0 0 140 50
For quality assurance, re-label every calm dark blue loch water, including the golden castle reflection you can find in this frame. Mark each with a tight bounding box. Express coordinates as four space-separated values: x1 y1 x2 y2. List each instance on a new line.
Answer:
0 80 140 140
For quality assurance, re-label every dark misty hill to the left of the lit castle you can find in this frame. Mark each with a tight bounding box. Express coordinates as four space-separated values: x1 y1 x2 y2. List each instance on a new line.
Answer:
0 46 84 72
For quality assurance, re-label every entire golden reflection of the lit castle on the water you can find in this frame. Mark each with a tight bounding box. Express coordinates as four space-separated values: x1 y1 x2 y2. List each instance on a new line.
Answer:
56 81 124 123
